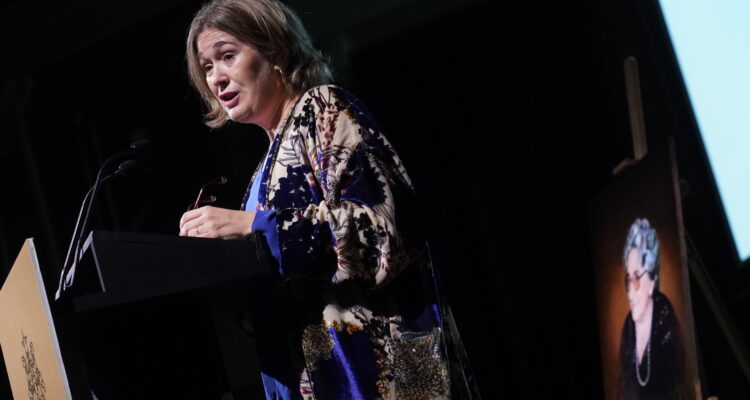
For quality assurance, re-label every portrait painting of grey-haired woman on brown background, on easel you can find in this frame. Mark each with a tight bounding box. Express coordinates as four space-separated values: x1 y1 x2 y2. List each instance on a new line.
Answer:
592 144 700 399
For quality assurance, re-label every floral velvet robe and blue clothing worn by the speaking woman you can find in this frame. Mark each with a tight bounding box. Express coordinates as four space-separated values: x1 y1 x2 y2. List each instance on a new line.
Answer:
243 86 466 400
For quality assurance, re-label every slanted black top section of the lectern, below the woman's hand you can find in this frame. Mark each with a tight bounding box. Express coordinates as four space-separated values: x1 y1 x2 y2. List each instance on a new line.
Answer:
71 231 272 311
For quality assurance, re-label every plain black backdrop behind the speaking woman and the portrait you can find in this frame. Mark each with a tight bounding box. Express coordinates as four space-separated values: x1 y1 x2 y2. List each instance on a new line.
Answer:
0 0 750 399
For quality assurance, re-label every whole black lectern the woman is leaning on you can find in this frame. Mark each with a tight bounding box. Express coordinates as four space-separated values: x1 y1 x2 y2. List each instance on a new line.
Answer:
55 231 279 400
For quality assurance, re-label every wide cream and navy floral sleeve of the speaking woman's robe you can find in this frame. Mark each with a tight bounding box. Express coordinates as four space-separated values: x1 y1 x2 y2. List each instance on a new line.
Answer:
275 86 418 285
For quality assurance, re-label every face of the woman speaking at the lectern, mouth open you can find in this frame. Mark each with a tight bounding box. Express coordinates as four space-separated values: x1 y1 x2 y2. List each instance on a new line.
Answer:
196 28 284 130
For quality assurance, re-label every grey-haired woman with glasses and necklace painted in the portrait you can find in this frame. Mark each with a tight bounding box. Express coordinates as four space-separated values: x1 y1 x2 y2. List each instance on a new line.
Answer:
620 218 681 399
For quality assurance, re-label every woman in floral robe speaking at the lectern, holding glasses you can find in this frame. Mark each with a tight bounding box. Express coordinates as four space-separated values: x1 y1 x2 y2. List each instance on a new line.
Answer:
180 0 476 400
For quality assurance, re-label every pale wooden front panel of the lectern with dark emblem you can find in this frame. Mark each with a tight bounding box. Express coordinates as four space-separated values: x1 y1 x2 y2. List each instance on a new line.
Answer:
0 239 71 400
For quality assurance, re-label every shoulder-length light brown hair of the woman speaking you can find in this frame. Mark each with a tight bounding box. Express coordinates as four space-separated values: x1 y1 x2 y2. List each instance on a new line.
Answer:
185 0 331 128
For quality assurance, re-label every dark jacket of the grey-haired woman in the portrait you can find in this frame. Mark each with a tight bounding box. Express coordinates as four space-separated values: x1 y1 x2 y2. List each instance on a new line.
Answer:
620 290 687 399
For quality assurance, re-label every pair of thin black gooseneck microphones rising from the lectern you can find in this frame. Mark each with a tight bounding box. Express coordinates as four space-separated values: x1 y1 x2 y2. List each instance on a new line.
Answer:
55 140 151 300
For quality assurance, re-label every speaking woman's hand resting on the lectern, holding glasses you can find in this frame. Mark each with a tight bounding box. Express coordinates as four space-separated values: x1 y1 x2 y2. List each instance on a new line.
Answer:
180 206 255 239
